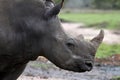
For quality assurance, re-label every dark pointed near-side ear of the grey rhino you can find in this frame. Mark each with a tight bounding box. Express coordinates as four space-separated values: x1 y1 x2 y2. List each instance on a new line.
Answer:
45 0 64 17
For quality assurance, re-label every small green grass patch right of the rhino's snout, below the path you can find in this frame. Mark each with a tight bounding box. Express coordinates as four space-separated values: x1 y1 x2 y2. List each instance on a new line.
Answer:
96 44 120 58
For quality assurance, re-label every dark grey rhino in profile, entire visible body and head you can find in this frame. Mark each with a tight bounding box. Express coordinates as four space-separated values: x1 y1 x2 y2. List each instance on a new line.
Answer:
0 0 104 80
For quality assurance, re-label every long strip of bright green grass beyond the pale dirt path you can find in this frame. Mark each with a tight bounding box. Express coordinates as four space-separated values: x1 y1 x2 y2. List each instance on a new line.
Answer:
59 12 120 29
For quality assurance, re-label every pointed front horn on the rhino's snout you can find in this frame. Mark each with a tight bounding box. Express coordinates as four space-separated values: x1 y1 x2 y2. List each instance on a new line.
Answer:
91 30 104 48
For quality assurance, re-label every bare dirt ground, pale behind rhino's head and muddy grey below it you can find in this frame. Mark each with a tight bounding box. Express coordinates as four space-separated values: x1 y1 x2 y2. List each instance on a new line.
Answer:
18 23 120 80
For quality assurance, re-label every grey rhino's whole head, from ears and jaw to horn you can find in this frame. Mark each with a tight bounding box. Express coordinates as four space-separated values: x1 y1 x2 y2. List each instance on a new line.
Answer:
42 0 104 72
